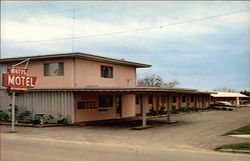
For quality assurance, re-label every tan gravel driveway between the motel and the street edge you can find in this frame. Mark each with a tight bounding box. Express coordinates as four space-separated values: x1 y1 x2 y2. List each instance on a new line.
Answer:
1 107 250 150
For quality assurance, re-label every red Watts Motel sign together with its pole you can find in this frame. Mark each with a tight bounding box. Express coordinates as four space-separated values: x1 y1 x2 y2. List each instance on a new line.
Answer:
2 59 36 132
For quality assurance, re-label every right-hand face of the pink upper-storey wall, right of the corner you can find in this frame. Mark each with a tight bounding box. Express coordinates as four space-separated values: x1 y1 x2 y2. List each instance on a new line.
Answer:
76 59 136 87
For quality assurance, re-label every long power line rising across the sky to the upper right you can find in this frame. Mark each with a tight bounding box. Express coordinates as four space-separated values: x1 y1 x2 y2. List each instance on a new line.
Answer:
3 9 250 43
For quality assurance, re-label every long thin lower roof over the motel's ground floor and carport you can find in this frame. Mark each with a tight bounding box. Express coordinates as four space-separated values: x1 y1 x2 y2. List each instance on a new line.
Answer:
29 87 213 94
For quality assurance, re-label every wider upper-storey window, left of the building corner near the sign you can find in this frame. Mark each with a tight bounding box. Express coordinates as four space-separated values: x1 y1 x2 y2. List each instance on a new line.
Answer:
44 63 64 76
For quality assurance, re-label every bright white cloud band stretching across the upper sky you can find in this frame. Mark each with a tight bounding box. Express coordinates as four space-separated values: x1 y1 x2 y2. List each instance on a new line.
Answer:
1 12 227 41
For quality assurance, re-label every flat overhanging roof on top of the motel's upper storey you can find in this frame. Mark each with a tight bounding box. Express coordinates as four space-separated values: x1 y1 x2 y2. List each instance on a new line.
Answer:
0 52 151 68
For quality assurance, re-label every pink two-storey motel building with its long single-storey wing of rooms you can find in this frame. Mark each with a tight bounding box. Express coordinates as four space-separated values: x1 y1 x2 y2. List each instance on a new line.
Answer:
0 53 246 125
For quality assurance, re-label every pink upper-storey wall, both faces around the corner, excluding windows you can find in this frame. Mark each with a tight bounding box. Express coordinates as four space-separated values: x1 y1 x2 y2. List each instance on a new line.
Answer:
4 59 136 88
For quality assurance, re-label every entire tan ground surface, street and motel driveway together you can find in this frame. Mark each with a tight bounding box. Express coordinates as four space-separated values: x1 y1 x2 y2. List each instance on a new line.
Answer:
1 108 250 161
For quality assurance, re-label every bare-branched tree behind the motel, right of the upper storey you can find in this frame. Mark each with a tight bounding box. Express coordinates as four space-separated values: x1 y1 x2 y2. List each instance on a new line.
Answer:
137 74 180 88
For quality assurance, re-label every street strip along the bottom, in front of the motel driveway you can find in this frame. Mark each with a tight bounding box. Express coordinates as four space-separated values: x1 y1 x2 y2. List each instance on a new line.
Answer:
1 137 250 161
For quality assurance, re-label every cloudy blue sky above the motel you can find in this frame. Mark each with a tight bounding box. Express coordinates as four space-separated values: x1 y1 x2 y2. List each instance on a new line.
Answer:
1 1 250 90
